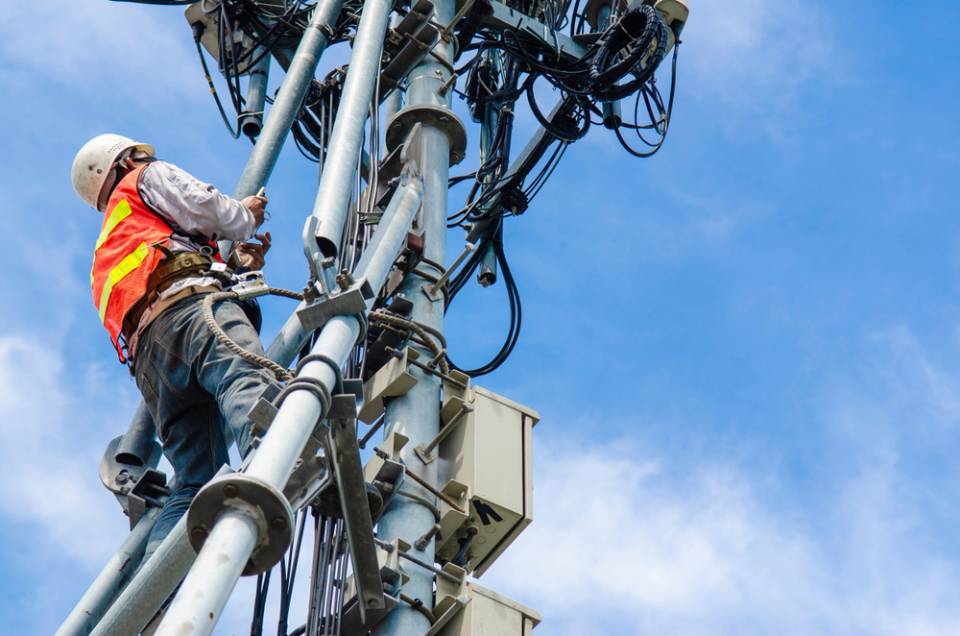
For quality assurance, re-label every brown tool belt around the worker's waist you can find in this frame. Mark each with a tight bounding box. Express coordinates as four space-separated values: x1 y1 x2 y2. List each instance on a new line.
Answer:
123 246 231 342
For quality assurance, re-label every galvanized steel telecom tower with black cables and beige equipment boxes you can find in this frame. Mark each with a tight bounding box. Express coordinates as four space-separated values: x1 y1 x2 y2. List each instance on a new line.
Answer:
58 0 688 636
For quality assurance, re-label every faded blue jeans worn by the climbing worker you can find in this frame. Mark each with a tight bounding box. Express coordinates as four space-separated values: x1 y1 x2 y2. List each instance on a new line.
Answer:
134 295 276 560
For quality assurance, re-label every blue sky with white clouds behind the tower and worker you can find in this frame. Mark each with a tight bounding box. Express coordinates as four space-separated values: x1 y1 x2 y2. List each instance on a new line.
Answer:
0 0 960 636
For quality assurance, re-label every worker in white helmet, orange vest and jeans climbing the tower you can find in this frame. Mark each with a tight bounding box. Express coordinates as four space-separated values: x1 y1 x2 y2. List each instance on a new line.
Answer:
72 134 276 561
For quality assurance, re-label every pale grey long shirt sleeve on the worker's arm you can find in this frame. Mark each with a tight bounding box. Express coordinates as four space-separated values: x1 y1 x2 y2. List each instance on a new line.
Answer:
140 161 263 241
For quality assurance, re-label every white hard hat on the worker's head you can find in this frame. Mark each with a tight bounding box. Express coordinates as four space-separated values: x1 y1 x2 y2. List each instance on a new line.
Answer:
70 133 155 212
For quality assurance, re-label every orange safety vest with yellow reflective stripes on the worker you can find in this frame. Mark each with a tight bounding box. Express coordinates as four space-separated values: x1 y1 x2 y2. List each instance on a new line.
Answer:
90 165 220 363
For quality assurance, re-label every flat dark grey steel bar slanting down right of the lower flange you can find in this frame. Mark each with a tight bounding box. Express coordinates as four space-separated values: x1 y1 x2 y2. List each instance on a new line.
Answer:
327 395 386 621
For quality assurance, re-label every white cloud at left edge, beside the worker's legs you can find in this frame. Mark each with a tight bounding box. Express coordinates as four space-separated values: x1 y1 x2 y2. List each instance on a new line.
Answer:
0 336 132 571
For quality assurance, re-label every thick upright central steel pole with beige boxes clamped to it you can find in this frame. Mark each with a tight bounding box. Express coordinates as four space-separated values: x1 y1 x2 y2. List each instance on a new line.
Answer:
375 0 455 636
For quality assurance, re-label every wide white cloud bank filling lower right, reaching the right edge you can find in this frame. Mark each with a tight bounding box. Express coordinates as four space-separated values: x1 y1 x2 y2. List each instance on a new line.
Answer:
483 328 960 636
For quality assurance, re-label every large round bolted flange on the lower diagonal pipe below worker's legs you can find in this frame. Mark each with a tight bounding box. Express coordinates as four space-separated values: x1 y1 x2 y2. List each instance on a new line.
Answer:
187 473 293 576
